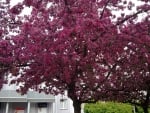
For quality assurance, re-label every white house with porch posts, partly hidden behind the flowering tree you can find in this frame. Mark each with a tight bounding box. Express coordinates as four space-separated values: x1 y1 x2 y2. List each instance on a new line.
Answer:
0 85 73 113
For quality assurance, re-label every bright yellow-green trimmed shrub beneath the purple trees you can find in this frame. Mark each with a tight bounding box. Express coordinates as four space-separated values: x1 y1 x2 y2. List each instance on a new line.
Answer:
84 102 143 113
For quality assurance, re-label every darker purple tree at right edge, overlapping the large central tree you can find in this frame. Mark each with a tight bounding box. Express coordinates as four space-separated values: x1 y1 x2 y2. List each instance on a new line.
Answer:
105 18 150 113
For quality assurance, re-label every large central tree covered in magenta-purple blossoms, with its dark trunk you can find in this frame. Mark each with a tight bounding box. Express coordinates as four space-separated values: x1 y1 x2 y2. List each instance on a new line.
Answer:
0 0 150 113
